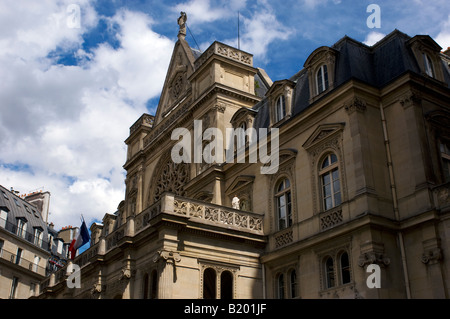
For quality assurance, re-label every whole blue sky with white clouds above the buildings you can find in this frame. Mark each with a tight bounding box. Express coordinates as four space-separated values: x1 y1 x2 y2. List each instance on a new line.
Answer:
0 0 450 229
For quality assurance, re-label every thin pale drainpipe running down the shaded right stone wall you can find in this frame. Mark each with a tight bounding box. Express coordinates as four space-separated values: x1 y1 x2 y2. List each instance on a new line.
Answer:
380 102 411 299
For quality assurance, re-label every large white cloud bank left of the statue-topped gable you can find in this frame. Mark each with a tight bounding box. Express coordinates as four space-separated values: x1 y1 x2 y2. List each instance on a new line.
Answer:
0 1 174 228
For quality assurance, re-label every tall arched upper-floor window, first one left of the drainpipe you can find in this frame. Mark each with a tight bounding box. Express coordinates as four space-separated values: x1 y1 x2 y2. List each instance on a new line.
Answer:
319 153 342 210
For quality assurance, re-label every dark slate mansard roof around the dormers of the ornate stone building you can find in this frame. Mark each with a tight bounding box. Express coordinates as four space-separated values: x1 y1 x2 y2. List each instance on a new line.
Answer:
253 30 450 129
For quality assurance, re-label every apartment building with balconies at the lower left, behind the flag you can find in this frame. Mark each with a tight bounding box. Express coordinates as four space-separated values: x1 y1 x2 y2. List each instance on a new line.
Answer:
0 185 66 299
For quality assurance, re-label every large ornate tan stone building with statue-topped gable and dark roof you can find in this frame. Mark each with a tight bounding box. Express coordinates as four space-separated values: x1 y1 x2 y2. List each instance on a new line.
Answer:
39 16 450 299
